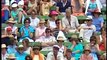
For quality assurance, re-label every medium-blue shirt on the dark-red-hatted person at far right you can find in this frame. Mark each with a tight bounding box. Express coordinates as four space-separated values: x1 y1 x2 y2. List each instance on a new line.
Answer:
92 17 104 32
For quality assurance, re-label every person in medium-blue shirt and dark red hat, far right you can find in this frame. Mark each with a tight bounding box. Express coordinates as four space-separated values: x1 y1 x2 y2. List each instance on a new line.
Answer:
92 11 104 44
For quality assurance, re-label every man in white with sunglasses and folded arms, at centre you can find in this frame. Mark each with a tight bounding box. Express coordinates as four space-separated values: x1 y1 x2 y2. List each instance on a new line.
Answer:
35 28 56 51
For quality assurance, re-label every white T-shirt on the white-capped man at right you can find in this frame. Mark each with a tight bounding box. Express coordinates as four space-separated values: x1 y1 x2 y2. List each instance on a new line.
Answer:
80 24 96 42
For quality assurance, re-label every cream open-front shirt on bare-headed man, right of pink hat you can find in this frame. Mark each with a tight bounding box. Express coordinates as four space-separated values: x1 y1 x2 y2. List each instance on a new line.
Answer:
62 15 79 30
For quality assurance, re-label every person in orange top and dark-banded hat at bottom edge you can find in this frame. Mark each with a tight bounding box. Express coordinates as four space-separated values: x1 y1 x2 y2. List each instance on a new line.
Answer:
31 45 45 60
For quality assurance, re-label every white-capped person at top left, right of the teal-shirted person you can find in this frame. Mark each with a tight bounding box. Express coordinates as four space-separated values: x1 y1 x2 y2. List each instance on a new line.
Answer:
18 1 27 24
